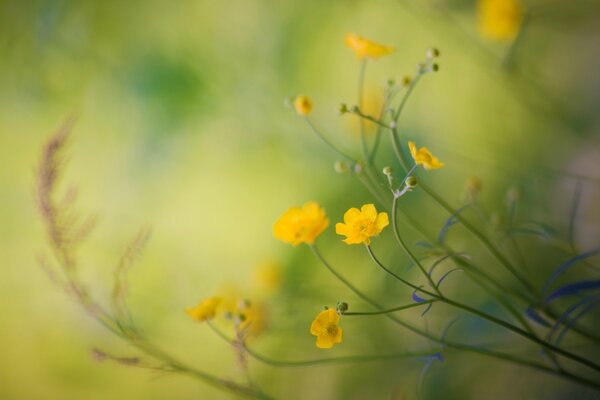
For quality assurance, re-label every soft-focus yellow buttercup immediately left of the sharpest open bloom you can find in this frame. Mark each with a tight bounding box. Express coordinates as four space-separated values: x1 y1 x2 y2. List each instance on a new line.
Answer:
273 201 329 246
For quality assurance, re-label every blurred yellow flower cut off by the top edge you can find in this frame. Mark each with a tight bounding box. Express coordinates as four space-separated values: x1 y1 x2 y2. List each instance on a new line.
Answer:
477 0 523 42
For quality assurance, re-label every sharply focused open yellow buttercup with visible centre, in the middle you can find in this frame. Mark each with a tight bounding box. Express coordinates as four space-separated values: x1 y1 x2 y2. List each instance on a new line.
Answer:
335 204 390 244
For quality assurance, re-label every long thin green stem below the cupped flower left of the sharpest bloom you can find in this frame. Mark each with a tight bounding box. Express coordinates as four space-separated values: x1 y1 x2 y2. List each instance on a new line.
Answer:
310 245 600 391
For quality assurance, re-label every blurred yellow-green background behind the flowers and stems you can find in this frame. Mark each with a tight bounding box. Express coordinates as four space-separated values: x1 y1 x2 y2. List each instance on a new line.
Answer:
0 0 600 400
